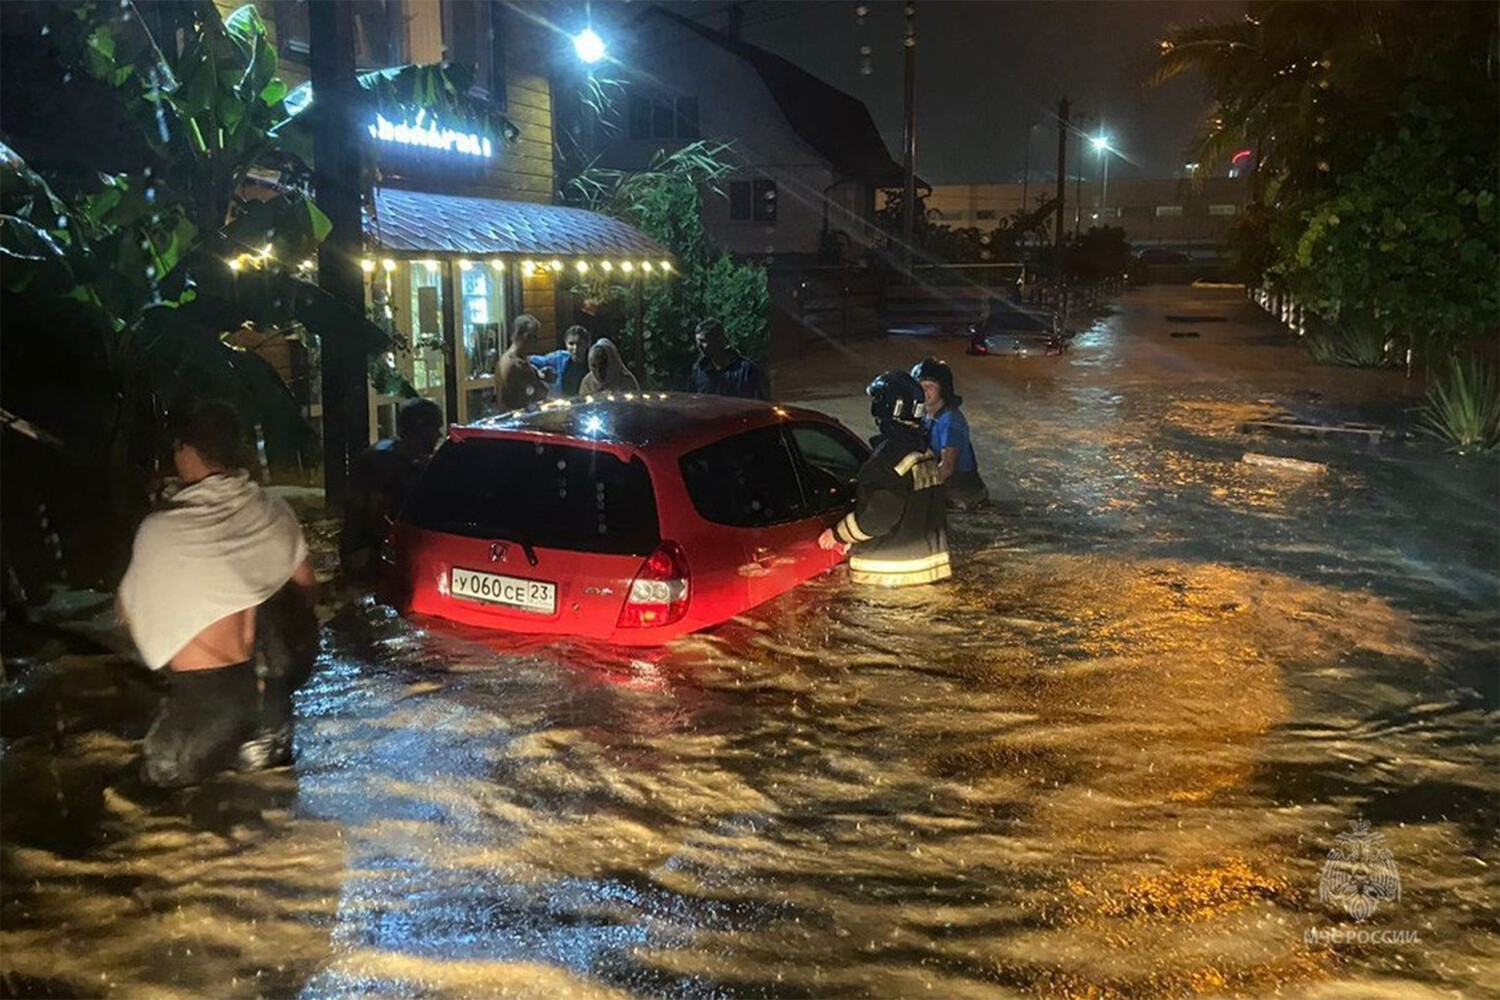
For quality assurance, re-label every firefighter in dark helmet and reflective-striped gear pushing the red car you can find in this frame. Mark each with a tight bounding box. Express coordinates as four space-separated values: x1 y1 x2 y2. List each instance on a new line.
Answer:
818 372 953 586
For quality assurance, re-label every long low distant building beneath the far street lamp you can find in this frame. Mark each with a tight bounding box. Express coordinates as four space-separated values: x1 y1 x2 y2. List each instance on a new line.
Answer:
927 177 1251 256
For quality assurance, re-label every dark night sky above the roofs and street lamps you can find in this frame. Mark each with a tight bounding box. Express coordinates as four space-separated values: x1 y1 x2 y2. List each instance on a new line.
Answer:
668 0 1244 184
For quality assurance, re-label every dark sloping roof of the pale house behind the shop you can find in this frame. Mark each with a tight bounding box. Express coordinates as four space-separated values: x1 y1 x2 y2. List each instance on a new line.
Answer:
650 6 906 187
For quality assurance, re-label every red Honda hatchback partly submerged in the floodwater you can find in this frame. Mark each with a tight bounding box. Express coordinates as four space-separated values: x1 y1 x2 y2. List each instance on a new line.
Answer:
389 393 870 645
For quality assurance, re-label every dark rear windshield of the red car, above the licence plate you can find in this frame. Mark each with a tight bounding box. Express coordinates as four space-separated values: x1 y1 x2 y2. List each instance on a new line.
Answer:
402 438 662 556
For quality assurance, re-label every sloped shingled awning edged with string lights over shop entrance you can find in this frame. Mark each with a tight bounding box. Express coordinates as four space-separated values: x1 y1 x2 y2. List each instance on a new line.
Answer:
366 187 671 259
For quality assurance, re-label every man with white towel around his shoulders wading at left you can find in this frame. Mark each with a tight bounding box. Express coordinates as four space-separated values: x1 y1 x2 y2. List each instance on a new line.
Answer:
116 402 318 787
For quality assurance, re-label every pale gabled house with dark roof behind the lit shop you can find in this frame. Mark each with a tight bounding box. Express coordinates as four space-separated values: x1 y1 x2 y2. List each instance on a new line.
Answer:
582 6 903 262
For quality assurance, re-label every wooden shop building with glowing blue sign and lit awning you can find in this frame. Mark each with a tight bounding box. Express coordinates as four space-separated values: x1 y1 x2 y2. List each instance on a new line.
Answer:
216 0 671 439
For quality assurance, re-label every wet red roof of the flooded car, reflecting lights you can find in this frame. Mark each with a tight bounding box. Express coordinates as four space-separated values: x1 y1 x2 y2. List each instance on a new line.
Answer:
449 393 837 451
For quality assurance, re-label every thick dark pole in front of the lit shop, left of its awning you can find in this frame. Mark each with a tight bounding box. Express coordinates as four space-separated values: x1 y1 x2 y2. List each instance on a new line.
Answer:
308 0 369 510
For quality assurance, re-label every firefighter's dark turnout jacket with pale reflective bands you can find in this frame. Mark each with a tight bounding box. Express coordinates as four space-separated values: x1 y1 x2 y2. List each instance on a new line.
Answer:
834 438 953 586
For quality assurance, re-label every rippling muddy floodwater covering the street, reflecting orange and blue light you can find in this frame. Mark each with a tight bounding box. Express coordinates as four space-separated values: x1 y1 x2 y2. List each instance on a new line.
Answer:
0 288 1500 999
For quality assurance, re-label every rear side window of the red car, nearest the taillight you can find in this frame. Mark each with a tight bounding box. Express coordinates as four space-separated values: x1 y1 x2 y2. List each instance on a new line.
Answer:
681 427 807 528
